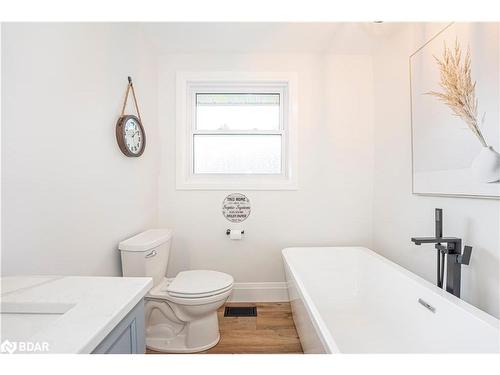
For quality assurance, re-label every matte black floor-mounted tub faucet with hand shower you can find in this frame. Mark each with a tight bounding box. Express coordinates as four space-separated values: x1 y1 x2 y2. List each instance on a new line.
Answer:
411 208 472 298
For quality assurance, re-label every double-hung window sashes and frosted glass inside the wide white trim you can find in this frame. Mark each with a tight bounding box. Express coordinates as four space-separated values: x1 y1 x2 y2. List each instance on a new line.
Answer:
193 93 283 174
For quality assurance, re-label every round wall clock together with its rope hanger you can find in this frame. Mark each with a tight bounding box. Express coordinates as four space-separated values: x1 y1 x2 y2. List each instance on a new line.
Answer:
116 77 146 158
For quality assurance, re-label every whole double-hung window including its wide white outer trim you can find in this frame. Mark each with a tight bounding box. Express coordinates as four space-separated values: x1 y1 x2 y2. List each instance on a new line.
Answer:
176 73 297 190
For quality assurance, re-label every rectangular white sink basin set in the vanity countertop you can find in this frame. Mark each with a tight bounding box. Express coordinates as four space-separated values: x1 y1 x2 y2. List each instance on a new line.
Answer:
0 302 75 341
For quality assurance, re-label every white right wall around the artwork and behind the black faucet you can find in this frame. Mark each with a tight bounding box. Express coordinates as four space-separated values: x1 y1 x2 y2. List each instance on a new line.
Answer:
373 24 500 317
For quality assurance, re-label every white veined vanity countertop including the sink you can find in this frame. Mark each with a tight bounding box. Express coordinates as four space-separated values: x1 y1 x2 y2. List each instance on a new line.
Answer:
1 276 153 353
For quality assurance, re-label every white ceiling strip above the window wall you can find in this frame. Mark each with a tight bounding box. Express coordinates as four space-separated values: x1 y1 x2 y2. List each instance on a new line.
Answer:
141 22 407 54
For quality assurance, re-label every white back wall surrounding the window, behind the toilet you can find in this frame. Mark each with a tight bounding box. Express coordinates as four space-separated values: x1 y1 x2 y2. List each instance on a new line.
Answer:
159 53 373 282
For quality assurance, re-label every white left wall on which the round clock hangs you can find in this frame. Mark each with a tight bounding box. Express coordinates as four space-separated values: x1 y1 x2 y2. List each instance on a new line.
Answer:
2 24 159 275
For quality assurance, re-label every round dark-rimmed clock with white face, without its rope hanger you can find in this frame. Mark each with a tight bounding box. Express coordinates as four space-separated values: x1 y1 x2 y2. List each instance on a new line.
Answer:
116 115 146 157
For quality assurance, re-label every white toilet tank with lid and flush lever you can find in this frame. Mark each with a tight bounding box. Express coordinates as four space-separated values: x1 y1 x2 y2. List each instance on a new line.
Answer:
118 229 172 285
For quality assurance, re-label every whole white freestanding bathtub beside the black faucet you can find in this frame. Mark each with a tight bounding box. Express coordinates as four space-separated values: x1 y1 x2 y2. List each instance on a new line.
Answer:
282 247 500 353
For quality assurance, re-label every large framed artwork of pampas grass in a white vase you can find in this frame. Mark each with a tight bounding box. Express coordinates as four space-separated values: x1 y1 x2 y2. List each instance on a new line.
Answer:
410 23 500 199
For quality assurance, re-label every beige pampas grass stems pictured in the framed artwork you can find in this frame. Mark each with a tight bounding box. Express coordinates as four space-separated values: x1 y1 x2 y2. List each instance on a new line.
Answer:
426 40 487 147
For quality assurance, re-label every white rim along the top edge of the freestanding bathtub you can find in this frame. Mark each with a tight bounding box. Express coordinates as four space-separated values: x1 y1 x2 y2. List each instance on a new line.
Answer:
281 246 500 353
